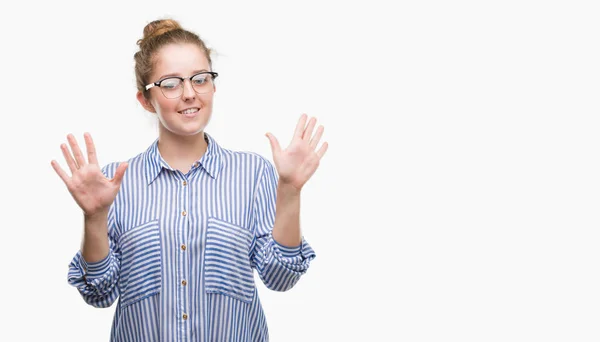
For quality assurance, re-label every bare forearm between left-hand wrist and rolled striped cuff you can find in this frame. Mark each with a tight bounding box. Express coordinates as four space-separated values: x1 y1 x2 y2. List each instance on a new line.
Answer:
81 211 109 263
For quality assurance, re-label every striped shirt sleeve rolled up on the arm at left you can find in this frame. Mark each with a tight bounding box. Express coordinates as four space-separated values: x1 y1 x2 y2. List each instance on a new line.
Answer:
67 163 121 308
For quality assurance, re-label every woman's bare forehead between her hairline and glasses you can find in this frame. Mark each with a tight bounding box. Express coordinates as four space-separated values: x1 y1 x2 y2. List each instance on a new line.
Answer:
152 44 210 77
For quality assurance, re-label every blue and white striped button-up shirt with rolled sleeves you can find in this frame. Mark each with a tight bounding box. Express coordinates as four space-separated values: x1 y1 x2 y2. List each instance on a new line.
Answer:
68 133 315 342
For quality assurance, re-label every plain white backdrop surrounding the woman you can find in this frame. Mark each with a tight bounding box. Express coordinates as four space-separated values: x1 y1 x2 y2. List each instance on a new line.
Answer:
0 0 600 342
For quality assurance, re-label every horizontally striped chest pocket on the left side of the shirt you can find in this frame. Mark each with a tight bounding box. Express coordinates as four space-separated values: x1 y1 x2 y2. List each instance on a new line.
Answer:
119 220 161 307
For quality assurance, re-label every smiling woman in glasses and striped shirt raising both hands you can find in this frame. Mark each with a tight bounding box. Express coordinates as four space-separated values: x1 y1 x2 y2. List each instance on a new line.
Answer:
52 20 328 341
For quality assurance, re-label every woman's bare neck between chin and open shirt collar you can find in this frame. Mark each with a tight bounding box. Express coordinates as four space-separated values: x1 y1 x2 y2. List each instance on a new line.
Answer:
158 129 208 173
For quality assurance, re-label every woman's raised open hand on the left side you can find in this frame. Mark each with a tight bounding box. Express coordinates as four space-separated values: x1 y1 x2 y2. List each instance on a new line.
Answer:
51 133 128 217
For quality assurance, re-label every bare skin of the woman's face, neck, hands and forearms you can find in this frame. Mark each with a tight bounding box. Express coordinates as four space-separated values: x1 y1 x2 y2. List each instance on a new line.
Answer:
51 44 328 262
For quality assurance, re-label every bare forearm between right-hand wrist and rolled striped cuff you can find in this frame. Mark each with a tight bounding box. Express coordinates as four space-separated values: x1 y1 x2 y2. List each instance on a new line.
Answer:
273 182 302 247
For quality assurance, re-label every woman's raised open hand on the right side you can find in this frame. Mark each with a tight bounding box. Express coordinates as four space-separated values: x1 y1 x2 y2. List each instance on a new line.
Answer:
266 114 328 191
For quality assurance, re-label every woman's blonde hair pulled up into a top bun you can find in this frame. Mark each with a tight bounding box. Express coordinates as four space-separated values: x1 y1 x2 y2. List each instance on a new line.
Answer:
133 19 212 99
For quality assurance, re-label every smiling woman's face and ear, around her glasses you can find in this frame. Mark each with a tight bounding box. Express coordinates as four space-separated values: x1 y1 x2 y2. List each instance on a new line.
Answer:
137 44 216 136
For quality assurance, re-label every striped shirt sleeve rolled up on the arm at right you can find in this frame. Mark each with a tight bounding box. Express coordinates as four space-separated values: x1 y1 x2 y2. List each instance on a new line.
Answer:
251 161 316 291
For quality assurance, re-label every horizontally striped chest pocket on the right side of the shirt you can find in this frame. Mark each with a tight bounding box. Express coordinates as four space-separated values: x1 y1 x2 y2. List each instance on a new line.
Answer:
204 218 254 303
